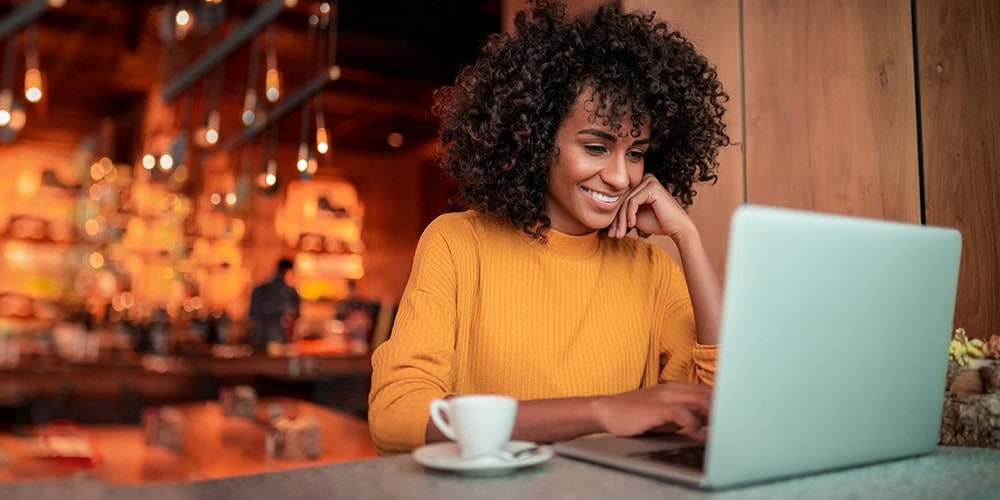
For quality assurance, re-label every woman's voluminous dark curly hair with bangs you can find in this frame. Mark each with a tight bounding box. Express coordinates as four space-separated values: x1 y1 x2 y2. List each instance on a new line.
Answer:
433 0 730 240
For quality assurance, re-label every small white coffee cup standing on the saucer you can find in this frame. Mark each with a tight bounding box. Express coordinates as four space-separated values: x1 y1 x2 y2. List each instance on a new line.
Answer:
430 394 517 458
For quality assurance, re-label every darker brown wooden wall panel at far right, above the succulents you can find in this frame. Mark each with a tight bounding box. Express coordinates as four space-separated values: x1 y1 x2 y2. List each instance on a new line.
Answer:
915 0 1000 337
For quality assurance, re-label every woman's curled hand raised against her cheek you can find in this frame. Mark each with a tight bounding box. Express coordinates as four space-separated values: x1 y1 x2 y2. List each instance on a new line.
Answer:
608 174 694 241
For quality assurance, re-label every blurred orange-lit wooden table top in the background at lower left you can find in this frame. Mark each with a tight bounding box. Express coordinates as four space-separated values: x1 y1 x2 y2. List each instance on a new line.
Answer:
0 397 377 484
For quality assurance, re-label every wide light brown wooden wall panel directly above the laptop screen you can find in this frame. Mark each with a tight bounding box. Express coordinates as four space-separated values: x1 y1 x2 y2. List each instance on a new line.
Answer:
743 0 920 222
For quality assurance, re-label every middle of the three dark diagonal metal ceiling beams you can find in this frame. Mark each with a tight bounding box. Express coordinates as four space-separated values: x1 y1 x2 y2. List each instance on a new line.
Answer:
162 0 298 102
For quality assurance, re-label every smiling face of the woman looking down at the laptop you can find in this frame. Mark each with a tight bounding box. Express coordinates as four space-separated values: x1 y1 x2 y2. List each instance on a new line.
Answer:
545 92 649 235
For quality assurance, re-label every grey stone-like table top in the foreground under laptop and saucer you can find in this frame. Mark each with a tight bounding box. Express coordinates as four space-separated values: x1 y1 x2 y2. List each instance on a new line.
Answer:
0 446 1000 500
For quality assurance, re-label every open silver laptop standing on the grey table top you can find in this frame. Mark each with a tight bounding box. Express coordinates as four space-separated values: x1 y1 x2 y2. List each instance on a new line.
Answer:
555 205 961 489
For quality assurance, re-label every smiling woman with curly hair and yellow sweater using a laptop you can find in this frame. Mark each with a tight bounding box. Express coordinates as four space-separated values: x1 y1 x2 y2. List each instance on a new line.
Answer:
369 1 729 453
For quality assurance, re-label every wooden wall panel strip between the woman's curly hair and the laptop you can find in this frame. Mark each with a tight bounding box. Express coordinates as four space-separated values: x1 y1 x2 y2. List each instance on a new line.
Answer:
623 0 744 276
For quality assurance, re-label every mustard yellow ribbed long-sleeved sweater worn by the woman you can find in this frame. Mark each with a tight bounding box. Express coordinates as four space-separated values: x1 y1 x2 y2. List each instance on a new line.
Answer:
368 211 717 453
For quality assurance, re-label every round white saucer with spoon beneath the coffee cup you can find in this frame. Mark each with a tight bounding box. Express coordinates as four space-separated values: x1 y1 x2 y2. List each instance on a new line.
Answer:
413 441 553 477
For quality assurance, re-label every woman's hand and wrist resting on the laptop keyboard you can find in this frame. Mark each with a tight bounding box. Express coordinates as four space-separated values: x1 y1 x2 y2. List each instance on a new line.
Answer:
594 382 712 441
